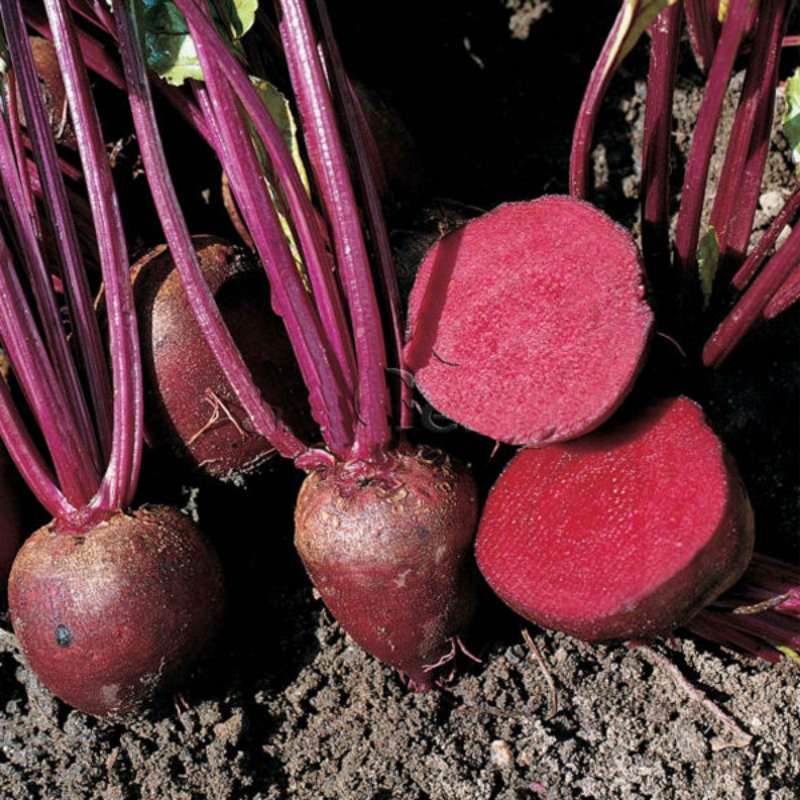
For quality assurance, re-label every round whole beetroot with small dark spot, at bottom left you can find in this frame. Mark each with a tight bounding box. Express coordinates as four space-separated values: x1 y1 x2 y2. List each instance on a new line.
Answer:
9 506 224 718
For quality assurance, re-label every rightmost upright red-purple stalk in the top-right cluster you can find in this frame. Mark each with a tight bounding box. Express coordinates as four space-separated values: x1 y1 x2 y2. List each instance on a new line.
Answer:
709 0 793 276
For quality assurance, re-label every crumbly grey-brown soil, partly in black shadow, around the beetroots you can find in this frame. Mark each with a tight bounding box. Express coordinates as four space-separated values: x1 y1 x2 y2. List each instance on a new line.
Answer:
0 0 800 800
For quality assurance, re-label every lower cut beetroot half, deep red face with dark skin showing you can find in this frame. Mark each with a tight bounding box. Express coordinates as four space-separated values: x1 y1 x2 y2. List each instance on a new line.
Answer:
477 397 753 641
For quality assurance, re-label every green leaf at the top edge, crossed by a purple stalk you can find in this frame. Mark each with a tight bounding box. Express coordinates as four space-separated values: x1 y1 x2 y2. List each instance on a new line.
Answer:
136 0 258 86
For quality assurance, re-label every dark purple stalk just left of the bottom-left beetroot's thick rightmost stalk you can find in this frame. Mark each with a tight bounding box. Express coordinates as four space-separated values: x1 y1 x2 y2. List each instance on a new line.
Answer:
0 0 112 456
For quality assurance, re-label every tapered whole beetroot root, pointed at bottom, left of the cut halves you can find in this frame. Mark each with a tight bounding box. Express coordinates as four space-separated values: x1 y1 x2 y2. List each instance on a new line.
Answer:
295 449 477 689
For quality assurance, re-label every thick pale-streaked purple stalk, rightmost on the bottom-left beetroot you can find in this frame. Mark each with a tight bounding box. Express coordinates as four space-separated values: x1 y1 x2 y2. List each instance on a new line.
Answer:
45 0 143 510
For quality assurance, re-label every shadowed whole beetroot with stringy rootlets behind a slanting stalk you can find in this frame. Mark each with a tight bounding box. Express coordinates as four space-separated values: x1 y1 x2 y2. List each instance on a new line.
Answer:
134 236 316 478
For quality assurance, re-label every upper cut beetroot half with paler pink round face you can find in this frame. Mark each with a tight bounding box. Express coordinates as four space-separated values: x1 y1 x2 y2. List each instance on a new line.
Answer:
405 196 653 445
